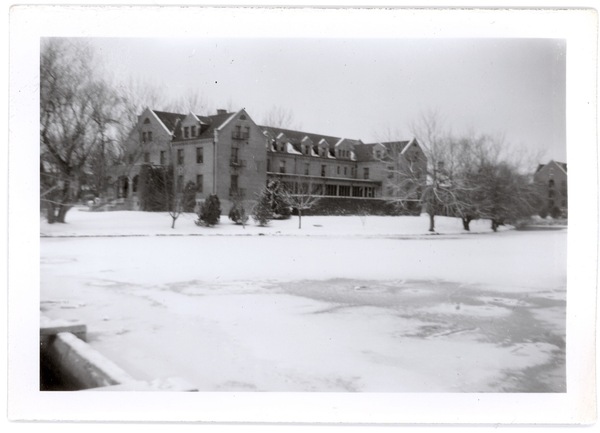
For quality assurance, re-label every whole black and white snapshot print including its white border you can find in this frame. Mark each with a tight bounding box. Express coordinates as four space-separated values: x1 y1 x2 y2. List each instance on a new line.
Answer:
9 1 598 423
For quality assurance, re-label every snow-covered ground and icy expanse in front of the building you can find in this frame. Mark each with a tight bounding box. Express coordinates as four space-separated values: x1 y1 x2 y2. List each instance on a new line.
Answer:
40 210 567 392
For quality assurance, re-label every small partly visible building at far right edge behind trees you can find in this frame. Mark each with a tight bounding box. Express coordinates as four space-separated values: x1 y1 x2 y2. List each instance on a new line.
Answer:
533 161 569 217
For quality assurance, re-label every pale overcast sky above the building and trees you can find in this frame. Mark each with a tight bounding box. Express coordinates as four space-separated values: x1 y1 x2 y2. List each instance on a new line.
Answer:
86 38 566 161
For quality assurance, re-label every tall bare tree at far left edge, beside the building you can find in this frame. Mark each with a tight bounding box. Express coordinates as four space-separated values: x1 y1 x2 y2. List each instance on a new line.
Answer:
40 39 119 222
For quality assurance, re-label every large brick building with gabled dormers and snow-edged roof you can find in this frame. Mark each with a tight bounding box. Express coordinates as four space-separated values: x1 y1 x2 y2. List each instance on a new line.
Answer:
115 109 427 211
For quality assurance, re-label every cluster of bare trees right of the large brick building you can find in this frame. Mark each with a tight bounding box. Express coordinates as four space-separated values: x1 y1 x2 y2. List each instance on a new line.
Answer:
388 112 542 232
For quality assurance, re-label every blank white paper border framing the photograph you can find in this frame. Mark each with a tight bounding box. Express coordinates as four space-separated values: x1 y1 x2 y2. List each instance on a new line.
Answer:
8 5 598 424
